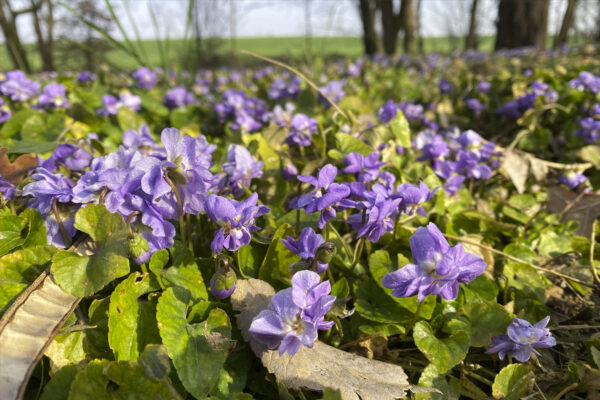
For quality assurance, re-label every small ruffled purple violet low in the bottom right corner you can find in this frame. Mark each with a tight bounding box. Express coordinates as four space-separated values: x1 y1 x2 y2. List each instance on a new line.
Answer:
486 317 556 362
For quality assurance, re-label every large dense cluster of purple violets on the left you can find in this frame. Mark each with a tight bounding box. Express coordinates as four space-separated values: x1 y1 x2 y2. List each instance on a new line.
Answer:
0 126 269 263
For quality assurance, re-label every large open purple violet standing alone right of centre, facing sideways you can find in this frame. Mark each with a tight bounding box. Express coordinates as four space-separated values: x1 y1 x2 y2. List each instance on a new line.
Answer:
382 222 486 301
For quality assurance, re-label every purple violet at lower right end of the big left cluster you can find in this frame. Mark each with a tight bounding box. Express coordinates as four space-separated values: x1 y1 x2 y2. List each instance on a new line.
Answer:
204 193 269 253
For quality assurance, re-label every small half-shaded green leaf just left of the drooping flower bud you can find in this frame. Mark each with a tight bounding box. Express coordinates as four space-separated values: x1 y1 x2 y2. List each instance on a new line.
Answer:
162 241 208 300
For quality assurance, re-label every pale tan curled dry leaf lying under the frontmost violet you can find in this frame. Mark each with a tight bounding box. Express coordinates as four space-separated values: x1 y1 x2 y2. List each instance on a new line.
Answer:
231 279 412 400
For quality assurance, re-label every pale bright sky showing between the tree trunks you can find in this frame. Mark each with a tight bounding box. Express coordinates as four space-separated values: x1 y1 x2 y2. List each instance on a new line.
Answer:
0 0 598 42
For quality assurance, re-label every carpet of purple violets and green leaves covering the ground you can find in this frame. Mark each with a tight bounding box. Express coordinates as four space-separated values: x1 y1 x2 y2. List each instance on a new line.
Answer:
0 42 600 399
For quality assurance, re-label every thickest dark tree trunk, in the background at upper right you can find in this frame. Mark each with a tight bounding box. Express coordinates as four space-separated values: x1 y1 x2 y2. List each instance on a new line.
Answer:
495 0 550 50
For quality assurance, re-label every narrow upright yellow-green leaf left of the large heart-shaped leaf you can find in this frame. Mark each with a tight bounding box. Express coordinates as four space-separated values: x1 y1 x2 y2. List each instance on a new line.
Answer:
108 272 157 361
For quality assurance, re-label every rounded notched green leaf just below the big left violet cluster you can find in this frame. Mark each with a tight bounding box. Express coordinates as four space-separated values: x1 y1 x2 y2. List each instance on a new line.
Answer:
52 205 129 297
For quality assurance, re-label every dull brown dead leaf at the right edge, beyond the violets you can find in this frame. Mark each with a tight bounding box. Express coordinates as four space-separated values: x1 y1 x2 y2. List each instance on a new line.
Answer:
548 186 600 237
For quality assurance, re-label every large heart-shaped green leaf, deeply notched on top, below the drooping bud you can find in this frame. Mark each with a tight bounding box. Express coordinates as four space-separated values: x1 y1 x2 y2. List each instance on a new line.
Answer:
156 287 231 399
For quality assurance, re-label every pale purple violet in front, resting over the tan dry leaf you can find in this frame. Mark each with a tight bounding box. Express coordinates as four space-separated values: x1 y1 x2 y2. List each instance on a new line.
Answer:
249 270 336 356
